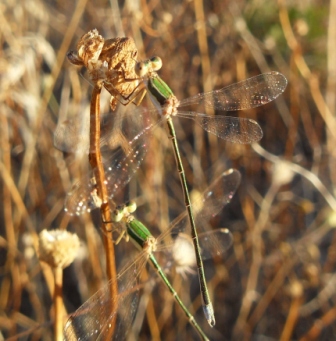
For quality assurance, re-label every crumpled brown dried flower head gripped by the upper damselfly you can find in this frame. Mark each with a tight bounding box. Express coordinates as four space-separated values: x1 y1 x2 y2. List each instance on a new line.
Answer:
67 29 139 110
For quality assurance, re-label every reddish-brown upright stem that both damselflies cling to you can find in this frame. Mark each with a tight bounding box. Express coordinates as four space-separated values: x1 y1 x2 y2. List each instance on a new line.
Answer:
89 83 118 335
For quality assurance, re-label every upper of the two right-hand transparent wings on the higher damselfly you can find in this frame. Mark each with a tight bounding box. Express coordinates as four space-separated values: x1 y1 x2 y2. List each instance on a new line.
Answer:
179 71 287 111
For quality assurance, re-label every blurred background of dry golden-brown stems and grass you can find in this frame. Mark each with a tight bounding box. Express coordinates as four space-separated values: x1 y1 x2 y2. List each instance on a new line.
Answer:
0 0 336 340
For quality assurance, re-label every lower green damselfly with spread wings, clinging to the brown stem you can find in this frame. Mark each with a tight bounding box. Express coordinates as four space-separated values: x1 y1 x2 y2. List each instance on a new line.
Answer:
64 169 240 340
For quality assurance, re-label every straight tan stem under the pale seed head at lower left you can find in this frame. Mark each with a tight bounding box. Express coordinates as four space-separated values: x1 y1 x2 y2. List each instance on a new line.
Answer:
54 267 63 341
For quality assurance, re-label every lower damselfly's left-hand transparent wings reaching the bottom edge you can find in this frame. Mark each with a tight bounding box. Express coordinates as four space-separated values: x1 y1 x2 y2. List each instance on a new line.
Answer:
64 253 146 341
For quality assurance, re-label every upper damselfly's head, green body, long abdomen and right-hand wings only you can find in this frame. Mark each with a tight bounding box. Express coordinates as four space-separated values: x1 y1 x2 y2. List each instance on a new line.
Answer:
135 57 287 327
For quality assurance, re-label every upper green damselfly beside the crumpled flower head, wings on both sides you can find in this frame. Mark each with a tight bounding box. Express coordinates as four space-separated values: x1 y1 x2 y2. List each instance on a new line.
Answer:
60 57 287 325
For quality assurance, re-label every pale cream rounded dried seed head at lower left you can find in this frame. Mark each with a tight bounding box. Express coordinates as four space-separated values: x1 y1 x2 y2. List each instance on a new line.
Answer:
39 230 79 269
